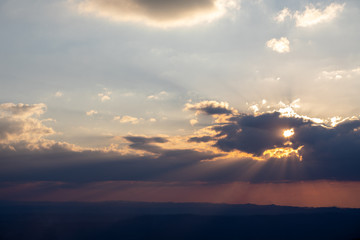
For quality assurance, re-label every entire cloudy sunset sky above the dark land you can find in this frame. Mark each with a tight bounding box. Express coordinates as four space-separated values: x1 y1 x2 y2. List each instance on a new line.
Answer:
0 0 360 208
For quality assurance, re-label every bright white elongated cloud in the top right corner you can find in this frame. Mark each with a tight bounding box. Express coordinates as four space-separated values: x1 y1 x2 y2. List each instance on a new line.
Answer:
275 3 345 27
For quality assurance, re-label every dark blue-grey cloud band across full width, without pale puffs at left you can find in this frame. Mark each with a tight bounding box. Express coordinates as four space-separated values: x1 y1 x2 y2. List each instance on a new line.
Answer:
0 109 360 182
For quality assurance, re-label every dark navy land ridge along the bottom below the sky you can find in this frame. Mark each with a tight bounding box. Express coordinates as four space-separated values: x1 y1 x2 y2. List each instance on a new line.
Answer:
0 202 360 240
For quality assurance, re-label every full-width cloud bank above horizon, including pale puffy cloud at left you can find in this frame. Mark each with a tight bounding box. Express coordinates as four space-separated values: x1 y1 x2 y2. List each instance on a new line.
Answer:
0 101 360 183
